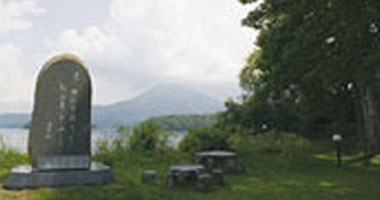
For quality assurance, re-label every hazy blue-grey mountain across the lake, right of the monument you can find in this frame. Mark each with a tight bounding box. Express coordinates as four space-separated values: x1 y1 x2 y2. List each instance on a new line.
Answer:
93 83 224 128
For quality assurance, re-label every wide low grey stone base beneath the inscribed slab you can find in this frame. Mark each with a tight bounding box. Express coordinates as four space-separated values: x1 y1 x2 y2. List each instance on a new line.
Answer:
4 163 114 190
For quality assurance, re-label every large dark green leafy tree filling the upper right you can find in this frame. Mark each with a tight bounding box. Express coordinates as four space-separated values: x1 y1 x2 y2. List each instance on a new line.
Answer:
232 0 380 152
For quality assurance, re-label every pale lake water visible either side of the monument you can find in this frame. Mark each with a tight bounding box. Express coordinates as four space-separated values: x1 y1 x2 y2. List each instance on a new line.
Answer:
0 128 185 153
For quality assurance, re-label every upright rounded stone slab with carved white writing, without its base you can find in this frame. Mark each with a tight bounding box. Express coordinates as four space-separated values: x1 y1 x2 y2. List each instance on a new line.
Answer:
28 55 91 169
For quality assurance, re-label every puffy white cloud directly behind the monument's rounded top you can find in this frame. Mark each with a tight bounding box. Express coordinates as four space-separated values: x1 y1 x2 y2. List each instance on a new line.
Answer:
45 27 138 103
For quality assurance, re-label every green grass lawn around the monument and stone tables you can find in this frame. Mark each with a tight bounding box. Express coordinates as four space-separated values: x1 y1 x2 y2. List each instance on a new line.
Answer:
0 141 380 200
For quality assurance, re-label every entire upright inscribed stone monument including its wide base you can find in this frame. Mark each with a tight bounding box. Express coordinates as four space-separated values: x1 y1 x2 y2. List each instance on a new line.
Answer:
4 54 113 189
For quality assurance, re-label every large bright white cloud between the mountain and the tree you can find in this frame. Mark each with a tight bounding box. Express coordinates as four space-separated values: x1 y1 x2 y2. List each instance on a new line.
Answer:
105 0 253 82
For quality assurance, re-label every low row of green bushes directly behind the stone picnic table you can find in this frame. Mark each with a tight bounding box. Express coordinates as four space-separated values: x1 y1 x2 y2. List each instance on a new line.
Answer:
179 121 309 157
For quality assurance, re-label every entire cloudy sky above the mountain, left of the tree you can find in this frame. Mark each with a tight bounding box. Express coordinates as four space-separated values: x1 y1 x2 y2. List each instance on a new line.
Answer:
0 0 257 113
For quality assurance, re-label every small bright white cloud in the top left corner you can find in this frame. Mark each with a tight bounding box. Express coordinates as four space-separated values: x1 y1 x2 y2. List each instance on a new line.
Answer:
0 0 45 34
